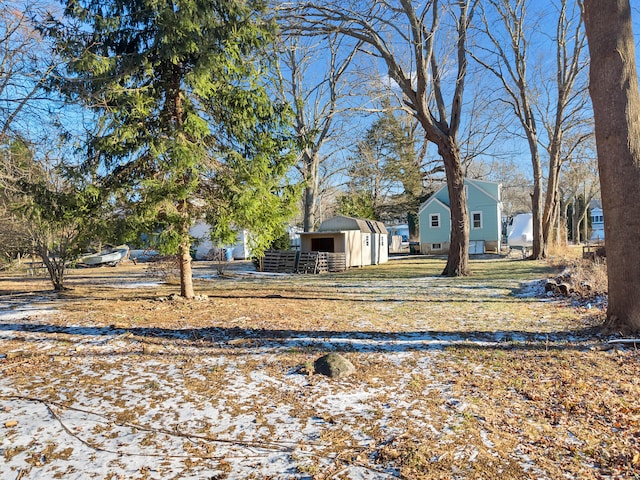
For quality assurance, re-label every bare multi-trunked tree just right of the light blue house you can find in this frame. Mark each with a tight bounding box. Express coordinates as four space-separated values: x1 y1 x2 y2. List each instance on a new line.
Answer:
473 0 588 258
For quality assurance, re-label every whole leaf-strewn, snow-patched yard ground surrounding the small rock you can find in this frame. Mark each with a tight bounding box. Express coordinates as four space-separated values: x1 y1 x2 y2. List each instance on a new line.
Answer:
0 257 640 480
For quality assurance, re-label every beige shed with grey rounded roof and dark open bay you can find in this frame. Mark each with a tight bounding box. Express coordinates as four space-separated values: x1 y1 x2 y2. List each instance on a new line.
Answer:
300 216 389 268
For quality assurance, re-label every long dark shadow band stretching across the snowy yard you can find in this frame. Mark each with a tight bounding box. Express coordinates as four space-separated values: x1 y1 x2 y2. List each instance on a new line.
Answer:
0 322 603 353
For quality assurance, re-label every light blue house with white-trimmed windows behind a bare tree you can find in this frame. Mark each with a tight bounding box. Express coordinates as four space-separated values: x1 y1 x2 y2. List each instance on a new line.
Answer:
418 178 502 254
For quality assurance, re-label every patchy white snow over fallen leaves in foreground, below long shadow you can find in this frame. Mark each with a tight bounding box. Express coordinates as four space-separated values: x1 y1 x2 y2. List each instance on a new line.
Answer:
0 312 462 480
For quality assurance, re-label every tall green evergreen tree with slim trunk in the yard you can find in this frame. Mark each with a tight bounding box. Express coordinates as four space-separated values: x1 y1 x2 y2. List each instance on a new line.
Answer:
43 0 293 298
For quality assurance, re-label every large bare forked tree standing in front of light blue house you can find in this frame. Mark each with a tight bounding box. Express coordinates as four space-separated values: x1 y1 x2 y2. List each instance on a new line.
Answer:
288 0 477 276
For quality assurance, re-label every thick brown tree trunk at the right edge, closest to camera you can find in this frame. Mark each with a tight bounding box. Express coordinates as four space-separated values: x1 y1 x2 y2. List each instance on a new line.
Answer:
584 0 640 332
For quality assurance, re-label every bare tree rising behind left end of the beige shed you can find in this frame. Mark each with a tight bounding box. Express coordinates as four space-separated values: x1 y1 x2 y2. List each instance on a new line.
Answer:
279 32 359 232
